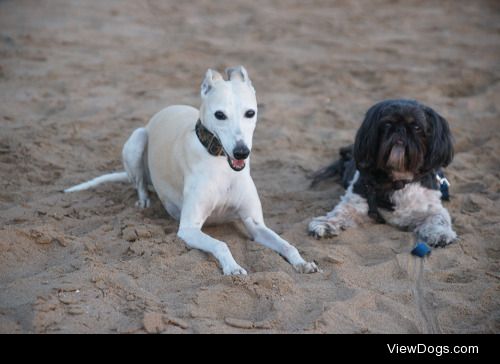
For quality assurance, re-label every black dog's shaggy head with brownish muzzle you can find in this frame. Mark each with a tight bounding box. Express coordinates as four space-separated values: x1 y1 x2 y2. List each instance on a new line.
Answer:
354 100 453 181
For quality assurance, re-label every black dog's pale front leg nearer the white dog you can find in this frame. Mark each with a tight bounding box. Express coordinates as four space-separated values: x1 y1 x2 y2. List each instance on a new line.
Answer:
309 172 368 239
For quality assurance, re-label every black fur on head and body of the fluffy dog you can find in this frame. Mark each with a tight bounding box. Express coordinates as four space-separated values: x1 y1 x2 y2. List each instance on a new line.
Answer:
311 99 453 223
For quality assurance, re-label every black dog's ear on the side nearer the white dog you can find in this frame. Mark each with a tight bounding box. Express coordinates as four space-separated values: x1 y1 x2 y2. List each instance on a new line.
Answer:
353 102 385 170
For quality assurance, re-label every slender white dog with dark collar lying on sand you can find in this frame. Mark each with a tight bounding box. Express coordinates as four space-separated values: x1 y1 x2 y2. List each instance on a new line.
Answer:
65 66 318 275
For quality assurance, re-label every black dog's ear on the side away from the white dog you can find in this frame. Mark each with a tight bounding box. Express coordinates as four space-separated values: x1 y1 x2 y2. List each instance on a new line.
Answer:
424 106 454 170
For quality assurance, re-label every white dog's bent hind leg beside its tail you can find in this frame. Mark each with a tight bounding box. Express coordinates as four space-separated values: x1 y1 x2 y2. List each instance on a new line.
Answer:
122 128 150 208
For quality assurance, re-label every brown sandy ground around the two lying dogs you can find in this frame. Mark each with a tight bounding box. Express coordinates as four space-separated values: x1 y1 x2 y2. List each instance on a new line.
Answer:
0 0 500 333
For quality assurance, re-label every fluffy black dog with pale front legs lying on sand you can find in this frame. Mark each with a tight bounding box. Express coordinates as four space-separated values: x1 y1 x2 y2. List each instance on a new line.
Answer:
309 99 456 246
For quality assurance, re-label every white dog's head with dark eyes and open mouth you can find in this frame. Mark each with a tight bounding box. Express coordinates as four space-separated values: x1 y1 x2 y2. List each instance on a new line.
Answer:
200 66 257 171
